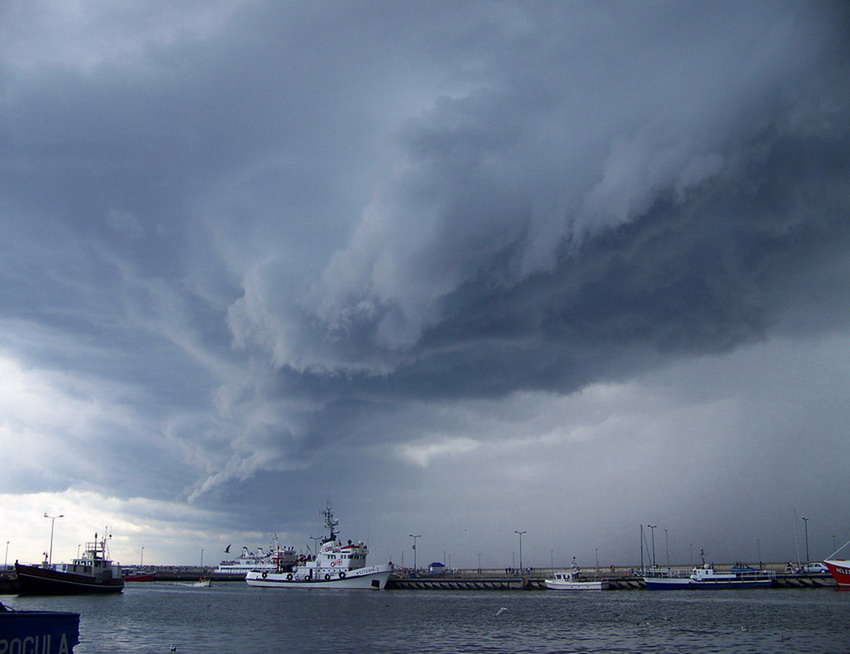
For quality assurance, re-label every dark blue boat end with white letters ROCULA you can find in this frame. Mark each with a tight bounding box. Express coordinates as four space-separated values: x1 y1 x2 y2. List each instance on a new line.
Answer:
0 603 80 654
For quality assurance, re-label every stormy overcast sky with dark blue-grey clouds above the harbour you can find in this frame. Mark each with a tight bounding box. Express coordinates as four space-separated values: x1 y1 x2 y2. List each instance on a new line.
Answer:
0 0 850 567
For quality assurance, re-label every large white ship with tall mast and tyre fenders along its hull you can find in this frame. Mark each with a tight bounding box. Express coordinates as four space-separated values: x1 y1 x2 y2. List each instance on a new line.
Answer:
245 503 392 590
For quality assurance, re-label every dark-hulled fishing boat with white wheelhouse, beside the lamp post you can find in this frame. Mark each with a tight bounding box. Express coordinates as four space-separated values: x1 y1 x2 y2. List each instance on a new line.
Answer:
15 534 124 595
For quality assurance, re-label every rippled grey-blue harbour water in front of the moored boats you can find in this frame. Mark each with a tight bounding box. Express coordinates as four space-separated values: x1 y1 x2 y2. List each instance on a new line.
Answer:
2 582 850 654
